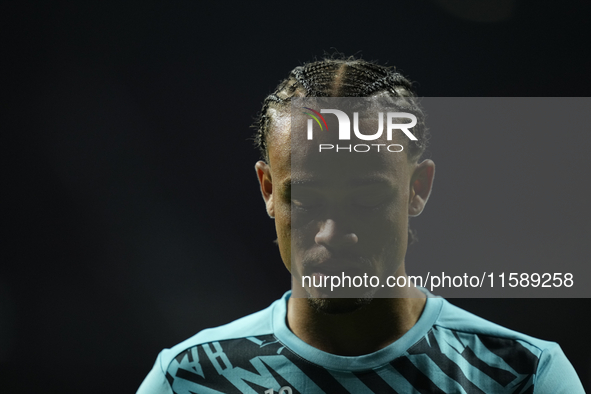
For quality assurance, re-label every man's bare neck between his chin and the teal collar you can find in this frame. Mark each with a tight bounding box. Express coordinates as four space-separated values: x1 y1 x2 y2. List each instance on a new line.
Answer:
287 278 426 356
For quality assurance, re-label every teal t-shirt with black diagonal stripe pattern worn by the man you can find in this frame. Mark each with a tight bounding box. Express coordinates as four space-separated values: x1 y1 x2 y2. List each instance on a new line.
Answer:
138 292 584 394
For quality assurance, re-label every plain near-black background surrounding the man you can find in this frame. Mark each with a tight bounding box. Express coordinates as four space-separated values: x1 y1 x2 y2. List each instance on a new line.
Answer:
0 0 591 393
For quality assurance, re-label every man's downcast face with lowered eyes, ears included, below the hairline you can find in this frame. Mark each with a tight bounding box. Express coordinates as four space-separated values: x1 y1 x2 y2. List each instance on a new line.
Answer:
256 110 434 311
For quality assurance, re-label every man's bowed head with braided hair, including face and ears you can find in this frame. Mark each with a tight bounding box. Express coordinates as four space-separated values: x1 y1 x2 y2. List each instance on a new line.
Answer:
256 59 434 312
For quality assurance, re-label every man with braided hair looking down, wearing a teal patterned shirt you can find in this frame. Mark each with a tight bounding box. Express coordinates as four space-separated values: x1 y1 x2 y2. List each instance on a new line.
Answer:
138 59 583 394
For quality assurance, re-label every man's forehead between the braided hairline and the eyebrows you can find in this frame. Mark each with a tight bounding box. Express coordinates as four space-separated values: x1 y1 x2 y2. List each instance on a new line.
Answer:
268 111 411 187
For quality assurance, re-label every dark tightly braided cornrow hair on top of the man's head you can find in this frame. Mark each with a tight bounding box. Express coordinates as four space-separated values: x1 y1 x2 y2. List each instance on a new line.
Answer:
253 58 428 163
